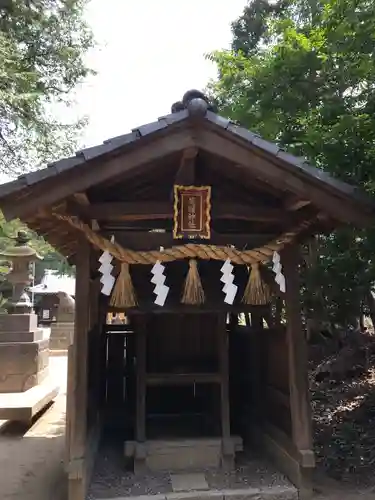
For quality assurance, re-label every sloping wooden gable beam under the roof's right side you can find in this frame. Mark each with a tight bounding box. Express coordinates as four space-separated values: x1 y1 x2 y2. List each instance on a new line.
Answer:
195 129 374 227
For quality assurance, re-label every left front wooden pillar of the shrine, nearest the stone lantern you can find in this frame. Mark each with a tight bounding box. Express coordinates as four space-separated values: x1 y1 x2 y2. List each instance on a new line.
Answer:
67 241 90 500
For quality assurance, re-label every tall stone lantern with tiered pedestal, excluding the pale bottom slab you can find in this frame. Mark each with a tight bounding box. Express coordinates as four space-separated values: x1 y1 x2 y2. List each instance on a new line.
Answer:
0 231 49 393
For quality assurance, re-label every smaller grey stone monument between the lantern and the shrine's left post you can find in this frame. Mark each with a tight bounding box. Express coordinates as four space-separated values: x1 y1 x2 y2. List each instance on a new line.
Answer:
50 292 75 351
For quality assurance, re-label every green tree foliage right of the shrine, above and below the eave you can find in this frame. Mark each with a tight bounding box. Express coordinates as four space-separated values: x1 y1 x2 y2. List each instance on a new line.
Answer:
208 0 375 323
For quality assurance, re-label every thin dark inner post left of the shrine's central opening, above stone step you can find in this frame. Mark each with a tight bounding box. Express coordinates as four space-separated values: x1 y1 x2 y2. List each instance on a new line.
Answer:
134 315 147 472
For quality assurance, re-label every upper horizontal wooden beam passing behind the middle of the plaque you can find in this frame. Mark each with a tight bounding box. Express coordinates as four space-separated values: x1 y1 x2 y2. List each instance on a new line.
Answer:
68 201 293 222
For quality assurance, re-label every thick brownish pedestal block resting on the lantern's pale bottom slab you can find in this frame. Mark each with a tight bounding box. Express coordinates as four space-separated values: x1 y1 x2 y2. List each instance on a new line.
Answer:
0 339 49 393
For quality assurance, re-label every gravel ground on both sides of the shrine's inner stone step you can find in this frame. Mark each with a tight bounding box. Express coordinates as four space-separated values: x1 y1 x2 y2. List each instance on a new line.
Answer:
87 443 291 500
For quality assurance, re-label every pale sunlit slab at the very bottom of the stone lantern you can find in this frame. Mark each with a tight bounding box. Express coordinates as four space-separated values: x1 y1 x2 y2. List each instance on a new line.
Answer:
0 379 59 422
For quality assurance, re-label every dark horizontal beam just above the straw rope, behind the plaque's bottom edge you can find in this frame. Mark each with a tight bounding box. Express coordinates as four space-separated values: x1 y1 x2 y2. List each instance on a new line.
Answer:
101 230 277 250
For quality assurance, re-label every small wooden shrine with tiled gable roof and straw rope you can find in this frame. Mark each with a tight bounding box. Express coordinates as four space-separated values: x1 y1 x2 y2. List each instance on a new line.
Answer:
0 91 374 500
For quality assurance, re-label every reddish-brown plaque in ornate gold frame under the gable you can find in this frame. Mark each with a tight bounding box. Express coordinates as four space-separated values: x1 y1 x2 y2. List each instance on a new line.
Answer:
173 185 211 239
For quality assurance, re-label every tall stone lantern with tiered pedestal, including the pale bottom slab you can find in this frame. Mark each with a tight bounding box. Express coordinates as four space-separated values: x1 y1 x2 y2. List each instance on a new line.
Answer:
0 231 57 420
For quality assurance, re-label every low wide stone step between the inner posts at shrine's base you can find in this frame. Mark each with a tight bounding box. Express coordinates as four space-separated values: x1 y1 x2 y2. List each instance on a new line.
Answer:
125 436 243 472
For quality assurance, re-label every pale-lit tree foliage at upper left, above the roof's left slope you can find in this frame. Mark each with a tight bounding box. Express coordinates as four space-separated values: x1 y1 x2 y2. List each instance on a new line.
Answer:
0 0 93 175
